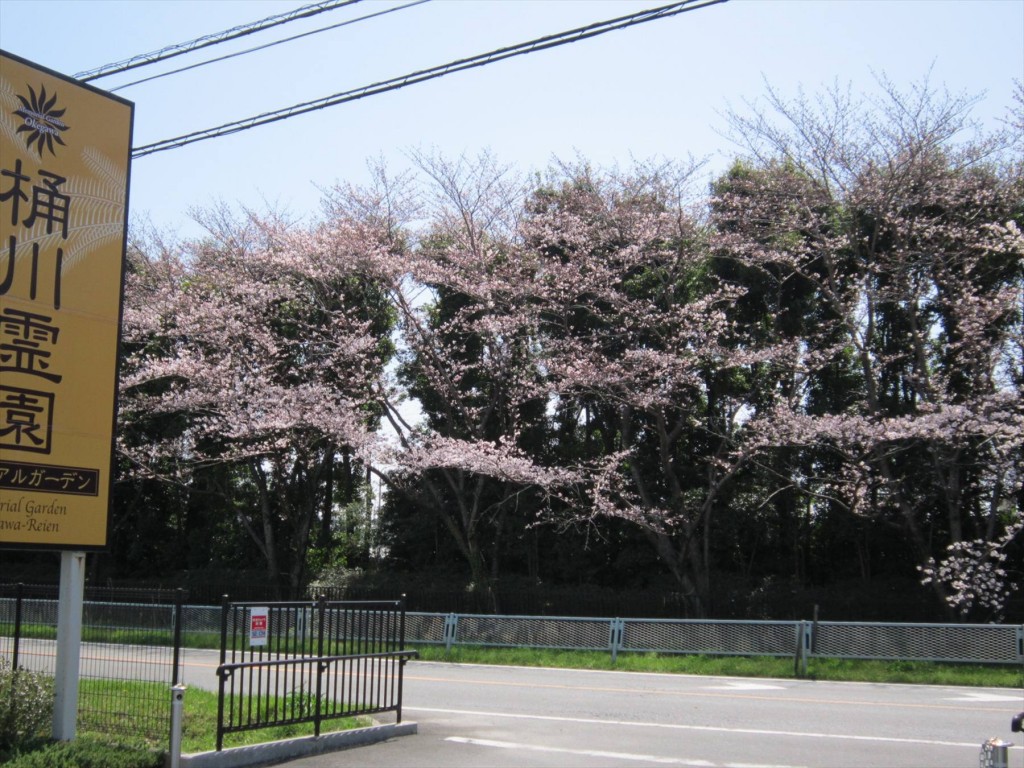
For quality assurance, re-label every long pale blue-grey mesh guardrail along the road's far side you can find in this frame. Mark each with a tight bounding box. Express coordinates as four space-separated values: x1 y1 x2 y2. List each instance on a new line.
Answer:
8 591 1024 680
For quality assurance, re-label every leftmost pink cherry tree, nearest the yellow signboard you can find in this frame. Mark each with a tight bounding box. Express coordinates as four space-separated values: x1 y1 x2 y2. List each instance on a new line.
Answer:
120 209 390 594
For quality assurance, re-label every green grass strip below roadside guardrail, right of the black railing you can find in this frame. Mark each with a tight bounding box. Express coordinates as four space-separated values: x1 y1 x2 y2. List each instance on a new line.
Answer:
407 645 1024 688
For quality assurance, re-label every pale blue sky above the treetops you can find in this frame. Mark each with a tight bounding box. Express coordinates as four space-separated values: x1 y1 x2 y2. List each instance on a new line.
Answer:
0 0 1024 234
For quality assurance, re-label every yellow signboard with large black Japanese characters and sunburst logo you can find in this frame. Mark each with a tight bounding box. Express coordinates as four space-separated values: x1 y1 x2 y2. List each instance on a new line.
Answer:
0 51 133 550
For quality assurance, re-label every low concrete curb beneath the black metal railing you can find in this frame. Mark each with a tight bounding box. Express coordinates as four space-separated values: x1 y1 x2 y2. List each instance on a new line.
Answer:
172 722 417 768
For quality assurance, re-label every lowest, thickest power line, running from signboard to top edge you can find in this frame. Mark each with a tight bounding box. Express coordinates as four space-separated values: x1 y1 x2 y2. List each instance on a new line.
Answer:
131 0 727 159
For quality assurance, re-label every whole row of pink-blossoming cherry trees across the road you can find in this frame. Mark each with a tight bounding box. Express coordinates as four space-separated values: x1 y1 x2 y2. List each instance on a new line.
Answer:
108 79 1024 617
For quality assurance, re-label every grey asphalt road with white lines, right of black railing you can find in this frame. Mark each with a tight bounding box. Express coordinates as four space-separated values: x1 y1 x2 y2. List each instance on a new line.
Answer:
272 663 1024 768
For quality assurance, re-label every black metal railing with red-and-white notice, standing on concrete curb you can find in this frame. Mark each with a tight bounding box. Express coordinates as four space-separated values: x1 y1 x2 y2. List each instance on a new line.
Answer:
217 598 417 751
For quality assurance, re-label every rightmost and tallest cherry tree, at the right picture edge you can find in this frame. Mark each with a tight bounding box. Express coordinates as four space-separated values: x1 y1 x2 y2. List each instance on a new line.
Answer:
714 78 1024 618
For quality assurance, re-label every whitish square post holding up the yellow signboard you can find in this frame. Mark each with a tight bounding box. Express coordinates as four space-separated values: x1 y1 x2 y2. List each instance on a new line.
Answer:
53 552 85 741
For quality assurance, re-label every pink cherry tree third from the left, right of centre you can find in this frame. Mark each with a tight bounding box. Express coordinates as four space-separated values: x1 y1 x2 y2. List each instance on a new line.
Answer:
524 159 775 615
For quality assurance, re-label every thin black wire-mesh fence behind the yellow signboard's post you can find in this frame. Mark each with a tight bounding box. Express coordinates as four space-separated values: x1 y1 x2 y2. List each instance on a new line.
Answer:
0 584 184 736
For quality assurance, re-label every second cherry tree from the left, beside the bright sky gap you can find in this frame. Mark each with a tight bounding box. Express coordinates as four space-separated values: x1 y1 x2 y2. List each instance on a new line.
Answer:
319 154 571 594
